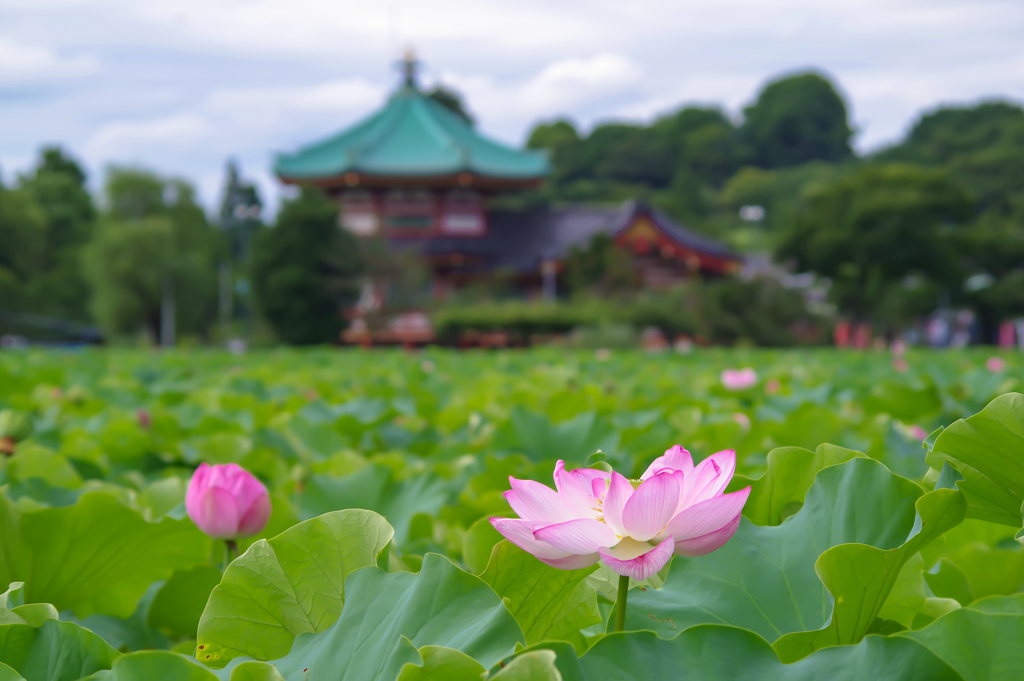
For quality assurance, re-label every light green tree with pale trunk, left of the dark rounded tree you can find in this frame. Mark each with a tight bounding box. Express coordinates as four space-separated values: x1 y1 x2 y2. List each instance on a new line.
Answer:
82 168 223 338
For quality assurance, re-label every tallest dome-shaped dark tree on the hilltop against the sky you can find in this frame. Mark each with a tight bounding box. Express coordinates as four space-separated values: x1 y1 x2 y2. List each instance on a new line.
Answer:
740 73 853 168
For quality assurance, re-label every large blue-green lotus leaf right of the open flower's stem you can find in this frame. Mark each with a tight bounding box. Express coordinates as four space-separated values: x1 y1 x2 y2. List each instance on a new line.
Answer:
627 458 922 641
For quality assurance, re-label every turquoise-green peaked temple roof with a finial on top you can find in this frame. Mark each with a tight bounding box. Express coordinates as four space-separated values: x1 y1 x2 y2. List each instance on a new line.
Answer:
274 70 550 181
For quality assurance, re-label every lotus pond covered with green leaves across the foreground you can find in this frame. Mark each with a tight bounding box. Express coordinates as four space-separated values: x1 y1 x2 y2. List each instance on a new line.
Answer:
0 349 1024 681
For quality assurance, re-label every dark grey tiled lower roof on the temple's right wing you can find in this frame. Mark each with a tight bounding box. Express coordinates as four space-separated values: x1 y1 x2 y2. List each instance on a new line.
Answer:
392 201 738 271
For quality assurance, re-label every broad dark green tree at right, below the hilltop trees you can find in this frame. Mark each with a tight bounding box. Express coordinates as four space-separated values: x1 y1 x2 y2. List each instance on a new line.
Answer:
777 164 973 321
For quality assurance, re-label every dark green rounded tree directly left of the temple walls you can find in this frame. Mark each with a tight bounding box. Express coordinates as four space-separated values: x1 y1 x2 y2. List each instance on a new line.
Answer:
252 187 362 344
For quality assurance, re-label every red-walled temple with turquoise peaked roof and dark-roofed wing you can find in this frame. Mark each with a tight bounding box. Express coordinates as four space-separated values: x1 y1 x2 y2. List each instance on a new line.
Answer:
274 55 740 298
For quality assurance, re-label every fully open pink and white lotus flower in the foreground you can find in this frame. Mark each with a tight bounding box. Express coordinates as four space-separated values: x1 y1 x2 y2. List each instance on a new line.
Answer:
490 444 751 580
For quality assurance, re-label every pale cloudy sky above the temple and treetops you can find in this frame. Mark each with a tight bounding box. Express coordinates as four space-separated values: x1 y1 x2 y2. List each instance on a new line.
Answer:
0 0 1024 213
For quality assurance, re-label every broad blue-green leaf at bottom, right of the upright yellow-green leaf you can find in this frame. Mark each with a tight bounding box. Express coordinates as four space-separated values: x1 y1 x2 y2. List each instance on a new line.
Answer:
252 553 525 681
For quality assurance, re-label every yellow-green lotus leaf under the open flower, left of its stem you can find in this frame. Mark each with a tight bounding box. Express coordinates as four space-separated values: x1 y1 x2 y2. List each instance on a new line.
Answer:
480 540 601 652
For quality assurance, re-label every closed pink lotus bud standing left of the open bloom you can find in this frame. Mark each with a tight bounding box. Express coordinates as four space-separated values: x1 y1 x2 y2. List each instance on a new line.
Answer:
185 463 270 540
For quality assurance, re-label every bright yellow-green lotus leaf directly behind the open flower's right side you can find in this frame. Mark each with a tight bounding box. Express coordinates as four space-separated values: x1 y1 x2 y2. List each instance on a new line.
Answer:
728 444 864 525
